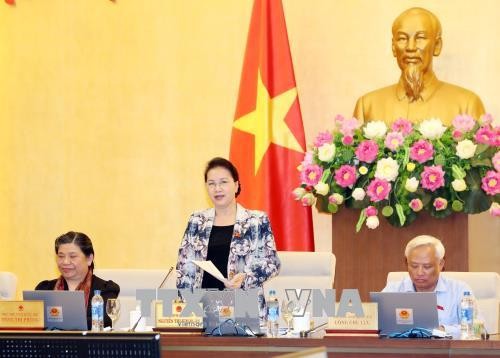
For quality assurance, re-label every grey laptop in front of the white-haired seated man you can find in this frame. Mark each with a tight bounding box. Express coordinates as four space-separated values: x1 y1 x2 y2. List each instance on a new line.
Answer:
370 292 439 335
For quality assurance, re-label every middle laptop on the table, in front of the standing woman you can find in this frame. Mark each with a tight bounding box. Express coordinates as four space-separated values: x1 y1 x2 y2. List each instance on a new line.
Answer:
201 290 263 336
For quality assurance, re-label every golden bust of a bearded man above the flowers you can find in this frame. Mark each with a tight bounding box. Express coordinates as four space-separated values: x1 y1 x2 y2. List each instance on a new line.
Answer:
354 8 485 125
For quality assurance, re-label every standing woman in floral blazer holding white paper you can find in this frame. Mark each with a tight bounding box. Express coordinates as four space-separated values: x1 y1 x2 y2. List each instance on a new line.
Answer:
177 157 280 316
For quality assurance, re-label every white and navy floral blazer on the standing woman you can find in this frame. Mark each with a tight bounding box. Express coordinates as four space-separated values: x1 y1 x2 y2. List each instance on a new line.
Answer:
177 204 280 316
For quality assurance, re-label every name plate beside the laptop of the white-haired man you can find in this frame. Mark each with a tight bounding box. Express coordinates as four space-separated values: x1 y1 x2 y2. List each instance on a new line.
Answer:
327 302 378 332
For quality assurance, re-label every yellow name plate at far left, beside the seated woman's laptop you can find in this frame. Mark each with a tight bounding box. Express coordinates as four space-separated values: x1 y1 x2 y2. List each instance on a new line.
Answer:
0 301 44 329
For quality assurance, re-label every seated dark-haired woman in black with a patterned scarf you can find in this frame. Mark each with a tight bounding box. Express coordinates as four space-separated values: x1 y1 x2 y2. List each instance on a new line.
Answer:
35 231 120 329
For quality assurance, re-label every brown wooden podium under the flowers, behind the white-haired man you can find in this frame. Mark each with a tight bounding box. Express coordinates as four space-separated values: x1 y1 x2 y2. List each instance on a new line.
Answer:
332 208 469 302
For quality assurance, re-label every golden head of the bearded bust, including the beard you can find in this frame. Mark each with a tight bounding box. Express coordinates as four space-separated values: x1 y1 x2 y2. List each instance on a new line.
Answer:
392 7 443 101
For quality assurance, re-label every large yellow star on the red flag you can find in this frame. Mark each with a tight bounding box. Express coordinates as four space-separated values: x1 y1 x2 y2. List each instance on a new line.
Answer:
233 71 304 173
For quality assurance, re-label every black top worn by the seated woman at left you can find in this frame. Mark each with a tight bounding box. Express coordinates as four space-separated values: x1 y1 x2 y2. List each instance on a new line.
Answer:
35 275 120 329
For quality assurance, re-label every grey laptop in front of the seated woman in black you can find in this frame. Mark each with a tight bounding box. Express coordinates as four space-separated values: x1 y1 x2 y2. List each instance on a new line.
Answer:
23 290 88 331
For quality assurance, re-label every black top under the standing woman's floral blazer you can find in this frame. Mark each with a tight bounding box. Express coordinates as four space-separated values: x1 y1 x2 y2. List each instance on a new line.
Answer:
201 225 234 290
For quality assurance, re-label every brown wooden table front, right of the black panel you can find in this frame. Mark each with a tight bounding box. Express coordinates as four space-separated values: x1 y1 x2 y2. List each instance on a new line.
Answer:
160 334 500 358
